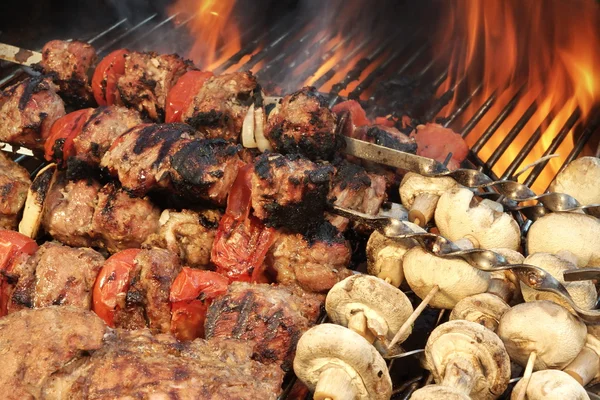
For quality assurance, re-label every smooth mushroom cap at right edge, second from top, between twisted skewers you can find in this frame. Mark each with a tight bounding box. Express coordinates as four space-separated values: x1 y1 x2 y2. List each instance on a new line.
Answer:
527 213 600 267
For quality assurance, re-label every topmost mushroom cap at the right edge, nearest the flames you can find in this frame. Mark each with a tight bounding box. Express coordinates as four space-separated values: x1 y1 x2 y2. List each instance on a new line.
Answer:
548 157 600 216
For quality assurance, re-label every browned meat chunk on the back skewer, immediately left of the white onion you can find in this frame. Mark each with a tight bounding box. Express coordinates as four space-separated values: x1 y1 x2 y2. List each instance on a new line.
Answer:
181 71 262 143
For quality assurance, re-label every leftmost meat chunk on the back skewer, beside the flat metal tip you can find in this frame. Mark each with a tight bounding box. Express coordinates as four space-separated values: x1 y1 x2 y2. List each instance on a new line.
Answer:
41 40 97 107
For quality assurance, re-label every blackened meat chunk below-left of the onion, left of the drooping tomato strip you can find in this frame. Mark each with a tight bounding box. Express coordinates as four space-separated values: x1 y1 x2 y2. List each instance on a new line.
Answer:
170 139 242 206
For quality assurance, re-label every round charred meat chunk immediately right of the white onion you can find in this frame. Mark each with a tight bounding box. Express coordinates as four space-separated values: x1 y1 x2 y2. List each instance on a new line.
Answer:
265 87 340 160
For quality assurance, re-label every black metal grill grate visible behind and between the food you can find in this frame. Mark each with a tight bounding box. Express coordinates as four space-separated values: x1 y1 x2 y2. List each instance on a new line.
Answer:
0 1 600 399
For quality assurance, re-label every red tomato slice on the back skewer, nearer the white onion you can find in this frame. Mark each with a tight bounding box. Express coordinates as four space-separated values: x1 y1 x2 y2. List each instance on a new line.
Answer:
165 71 214 122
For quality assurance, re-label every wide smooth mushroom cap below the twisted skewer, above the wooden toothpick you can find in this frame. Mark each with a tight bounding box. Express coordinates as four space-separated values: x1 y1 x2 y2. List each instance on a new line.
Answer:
402 247 490 309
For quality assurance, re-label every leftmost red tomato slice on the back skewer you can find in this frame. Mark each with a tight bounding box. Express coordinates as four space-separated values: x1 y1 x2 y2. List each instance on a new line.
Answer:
92 49 129 106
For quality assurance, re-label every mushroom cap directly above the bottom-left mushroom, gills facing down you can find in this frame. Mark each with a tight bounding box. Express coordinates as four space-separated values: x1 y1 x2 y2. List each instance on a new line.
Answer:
325 275 413 342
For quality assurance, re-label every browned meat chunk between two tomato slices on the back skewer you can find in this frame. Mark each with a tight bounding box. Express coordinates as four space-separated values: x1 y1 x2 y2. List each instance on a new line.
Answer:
117 51 191 122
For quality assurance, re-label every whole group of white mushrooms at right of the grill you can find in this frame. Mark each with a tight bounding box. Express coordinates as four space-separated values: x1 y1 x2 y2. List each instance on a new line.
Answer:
294 157 600 400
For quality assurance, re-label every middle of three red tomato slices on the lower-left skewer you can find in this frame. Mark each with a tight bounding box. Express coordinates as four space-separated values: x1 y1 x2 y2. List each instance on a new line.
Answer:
92 249 141 327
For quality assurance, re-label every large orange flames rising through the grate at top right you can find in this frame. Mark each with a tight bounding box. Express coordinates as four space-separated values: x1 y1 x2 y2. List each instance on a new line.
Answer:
438 0 600 192
